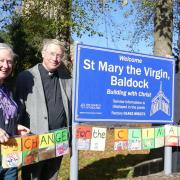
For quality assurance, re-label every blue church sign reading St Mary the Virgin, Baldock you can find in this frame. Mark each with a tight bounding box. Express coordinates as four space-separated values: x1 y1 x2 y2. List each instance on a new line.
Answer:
73 44 175 123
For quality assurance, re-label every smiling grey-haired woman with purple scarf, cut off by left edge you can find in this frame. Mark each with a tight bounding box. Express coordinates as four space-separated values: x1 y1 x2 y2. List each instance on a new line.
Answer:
0 43 29 180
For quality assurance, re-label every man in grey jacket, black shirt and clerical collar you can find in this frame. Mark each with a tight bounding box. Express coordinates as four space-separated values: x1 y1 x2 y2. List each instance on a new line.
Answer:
16 39 72 180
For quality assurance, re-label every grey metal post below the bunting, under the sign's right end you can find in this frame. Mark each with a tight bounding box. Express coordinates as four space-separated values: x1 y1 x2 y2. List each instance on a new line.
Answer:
164 147 172 175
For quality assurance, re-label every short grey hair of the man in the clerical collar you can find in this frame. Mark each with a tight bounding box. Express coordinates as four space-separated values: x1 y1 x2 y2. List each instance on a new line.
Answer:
42 39 65 55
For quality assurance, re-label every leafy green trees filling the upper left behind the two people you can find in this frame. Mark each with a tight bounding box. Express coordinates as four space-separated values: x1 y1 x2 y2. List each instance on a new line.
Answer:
0 0 107 76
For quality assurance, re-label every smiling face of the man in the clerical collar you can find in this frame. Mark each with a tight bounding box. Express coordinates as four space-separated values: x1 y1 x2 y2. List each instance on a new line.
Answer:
42 44 63 72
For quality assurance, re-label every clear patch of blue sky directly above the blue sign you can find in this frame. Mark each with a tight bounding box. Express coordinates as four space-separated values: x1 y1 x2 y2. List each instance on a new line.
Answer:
73 3 153 55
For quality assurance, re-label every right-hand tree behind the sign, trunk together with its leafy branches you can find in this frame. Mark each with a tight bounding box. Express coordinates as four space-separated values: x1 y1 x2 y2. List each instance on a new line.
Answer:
122 0 180 56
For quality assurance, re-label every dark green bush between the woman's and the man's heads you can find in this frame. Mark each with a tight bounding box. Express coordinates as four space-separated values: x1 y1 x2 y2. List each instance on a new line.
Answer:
7 15 40 74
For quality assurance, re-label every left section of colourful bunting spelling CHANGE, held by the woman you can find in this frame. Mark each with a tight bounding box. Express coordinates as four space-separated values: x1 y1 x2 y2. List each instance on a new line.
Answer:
1 128 69 168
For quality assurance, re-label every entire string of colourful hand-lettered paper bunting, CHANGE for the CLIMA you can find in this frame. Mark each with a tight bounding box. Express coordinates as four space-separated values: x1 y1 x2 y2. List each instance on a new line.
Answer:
1 125 180 168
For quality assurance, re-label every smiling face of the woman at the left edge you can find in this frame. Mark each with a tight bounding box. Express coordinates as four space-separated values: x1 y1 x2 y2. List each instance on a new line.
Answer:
0 49 13 84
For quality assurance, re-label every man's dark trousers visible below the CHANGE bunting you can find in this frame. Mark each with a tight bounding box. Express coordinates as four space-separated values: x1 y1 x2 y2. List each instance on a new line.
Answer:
22 156 63 180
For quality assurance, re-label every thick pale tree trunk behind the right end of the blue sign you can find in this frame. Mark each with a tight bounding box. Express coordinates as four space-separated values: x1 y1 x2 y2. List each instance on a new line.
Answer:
154 0 173 56
